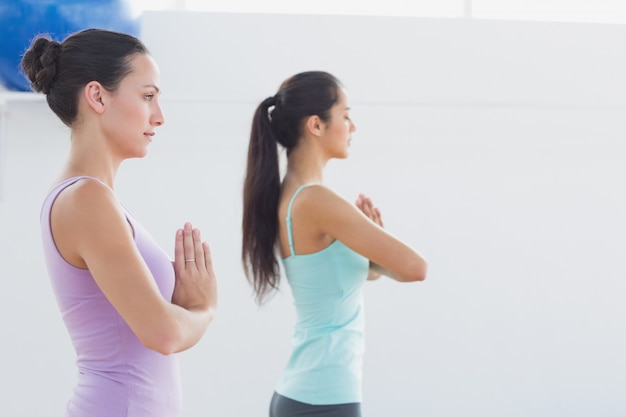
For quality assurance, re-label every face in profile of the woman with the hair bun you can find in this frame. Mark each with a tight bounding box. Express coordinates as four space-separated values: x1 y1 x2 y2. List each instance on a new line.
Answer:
102 54 165 159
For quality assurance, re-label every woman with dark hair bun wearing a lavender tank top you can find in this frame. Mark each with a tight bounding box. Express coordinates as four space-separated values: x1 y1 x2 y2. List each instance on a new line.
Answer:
21 29 217 417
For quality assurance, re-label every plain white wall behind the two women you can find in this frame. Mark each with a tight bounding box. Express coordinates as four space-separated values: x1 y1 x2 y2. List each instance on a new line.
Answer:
0 12 626 417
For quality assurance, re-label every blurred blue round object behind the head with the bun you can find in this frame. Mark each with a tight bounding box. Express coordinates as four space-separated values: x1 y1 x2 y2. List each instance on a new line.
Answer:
0 0 140 91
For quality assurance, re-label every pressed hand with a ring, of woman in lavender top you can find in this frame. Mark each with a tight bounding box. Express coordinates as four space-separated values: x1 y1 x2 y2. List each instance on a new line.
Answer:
172 222 217 310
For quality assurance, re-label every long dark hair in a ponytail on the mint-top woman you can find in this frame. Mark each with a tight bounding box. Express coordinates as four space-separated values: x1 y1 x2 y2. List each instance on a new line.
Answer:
241 71 341 304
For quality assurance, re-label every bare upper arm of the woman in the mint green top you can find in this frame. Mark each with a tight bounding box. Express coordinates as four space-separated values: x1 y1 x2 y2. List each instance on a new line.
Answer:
306 186 426 281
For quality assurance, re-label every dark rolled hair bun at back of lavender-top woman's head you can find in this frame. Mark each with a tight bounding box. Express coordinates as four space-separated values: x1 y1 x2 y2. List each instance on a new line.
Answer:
22 37 61 94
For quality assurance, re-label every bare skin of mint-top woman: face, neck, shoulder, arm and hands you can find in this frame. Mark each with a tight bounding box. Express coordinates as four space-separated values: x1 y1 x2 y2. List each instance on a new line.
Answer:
279 90 427 282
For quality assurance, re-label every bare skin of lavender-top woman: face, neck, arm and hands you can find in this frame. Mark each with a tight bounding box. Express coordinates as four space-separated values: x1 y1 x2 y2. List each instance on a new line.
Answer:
50 55 217 355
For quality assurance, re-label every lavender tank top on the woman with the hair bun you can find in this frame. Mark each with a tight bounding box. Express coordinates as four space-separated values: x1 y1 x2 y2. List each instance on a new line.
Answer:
41 177 182 417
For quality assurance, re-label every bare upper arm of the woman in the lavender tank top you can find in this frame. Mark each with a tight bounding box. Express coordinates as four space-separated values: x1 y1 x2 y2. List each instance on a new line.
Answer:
52 181 175 350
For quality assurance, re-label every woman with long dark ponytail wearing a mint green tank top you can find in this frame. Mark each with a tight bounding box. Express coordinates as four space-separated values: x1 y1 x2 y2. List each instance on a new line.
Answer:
242 71 426 417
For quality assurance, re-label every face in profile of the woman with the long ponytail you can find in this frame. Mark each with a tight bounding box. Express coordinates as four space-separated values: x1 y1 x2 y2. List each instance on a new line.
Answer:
322 89 356 158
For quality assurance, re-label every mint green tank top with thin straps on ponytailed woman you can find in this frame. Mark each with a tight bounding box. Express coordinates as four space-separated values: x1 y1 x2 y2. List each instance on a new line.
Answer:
276 185 369 405
